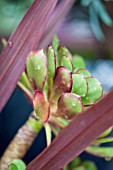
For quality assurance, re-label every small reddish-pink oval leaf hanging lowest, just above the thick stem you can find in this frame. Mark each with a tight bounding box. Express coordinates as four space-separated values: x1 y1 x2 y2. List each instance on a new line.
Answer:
33 90 50 123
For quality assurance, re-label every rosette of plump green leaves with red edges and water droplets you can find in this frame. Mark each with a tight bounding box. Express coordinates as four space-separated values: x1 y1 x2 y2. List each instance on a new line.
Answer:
26 36 103 123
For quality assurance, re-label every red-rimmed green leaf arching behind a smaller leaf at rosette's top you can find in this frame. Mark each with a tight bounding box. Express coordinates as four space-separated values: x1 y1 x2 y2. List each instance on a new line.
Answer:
58 46 72 63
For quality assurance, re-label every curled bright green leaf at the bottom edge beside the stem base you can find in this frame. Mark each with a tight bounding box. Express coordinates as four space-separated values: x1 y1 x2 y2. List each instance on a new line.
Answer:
8 159 26 170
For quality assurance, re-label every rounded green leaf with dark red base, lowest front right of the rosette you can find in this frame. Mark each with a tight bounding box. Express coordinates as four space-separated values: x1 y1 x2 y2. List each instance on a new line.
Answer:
57 93 83 119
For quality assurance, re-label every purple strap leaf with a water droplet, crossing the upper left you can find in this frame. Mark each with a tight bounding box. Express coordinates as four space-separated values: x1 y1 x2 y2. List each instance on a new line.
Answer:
0 0 57 111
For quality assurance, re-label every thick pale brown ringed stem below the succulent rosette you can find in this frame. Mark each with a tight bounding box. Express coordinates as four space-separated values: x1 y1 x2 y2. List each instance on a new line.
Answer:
0 114 42 170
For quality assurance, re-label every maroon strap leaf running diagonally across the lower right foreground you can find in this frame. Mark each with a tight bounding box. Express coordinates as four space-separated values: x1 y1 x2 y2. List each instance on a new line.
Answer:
27 90 113 170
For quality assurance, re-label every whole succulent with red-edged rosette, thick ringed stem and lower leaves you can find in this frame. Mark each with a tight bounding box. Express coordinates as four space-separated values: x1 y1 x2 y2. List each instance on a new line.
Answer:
1 35 113 170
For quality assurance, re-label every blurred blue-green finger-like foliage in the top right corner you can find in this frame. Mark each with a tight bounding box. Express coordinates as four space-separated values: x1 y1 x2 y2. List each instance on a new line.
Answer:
81 0 113 41
